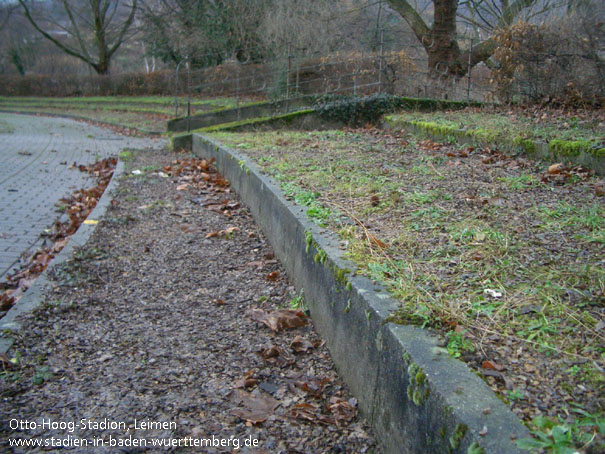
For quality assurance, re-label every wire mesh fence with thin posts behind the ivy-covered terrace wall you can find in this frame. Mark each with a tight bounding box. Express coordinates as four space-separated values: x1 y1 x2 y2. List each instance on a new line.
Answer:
174 34 493 115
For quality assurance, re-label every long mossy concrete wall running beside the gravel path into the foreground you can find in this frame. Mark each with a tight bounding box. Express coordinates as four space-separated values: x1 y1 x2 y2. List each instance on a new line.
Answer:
185 134 527 454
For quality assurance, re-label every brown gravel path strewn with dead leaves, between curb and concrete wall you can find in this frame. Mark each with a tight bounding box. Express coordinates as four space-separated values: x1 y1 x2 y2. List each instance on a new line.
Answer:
0 147 380 453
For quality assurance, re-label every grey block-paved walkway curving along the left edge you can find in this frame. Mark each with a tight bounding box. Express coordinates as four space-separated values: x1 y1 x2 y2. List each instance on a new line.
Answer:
0 113 166 279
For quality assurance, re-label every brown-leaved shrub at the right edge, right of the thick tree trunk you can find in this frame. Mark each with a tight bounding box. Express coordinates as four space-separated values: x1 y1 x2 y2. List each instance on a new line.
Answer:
492 3 605 104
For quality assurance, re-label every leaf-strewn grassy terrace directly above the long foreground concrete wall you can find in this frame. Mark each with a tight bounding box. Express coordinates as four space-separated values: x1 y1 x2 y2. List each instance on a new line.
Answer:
205 114 605 452
